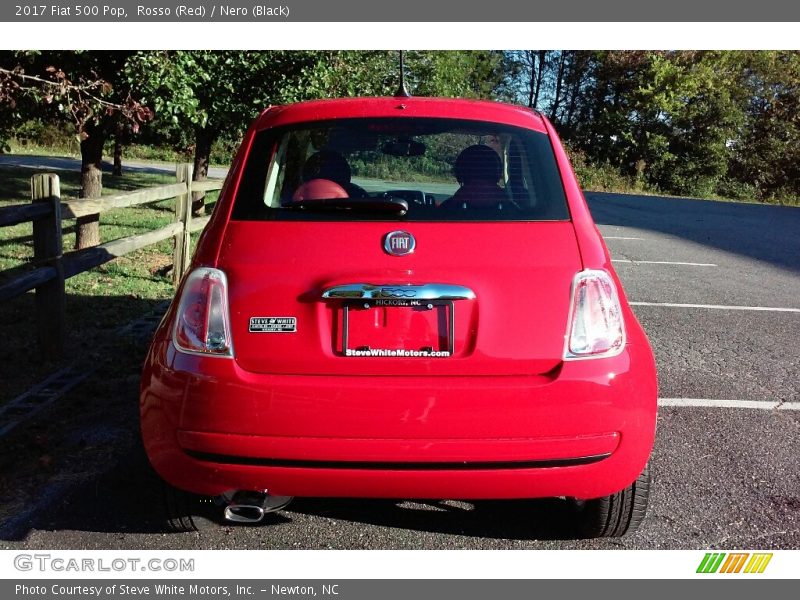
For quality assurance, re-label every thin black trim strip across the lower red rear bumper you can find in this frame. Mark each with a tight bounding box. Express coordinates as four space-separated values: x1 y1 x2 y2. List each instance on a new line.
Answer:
184 450 611 471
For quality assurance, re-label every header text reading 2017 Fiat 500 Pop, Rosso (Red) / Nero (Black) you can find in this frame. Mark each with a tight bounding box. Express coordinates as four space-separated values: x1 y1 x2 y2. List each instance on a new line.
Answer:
13 3 290 21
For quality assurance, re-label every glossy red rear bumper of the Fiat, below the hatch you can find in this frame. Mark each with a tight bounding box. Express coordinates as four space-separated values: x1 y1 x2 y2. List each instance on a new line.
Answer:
141 341 656 499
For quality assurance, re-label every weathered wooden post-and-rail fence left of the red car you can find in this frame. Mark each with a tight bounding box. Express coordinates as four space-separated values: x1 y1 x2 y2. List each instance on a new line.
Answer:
0 165 222 358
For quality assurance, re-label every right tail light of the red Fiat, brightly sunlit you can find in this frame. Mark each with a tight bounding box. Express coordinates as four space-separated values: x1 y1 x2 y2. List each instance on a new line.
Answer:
564 270 625 359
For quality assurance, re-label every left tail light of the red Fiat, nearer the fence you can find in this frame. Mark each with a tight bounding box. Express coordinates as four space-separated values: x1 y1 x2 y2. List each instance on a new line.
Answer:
172 267 233 356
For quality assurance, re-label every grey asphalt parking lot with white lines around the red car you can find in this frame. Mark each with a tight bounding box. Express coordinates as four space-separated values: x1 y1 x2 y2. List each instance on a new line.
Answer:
0 194 800 549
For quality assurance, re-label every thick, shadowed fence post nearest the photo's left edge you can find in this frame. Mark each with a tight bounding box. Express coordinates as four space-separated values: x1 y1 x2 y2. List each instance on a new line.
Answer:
31 173 66 359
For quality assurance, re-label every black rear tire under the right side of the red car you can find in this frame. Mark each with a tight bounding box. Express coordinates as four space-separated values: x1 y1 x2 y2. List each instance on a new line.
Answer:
578 465 651 538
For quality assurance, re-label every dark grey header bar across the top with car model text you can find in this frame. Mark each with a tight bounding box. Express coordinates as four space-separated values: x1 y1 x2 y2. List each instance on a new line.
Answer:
0 0 800 23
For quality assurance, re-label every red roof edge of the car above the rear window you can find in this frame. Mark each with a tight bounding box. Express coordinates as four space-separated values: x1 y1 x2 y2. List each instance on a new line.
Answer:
256 97 547 133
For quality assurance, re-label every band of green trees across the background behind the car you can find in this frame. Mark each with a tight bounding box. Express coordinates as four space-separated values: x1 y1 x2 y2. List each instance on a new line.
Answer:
0 50 800 203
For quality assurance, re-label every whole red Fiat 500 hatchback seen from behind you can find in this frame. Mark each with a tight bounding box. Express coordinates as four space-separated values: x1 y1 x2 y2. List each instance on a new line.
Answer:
141 98 656 536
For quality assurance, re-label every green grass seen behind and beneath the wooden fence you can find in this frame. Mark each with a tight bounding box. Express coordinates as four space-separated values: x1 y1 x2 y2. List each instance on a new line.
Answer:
0 167 216 402
